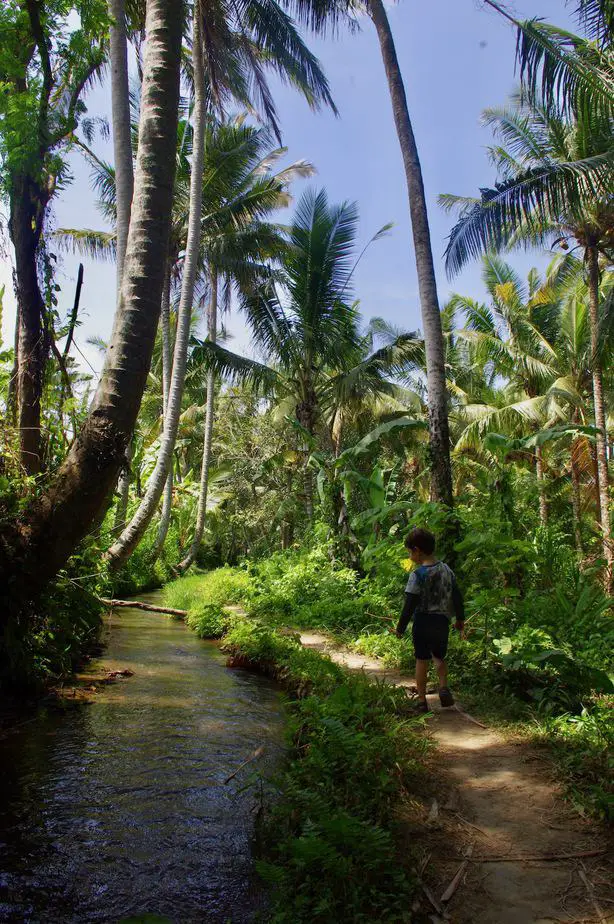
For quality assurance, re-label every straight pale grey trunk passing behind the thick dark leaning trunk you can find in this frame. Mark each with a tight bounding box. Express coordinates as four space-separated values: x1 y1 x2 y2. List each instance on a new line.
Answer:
109 0 134 535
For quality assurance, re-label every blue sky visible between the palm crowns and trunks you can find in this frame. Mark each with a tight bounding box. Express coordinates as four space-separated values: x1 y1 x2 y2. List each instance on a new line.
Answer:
0 0 570 370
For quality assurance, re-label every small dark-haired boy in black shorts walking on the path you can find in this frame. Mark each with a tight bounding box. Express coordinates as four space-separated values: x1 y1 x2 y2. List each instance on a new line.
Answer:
395 529 465 712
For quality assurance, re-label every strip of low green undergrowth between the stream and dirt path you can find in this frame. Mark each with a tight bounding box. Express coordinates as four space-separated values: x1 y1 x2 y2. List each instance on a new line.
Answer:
223 619 428 924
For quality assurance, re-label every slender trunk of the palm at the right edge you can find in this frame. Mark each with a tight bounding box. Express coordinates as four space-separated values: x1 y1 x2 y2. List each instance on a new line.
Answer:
586 245 614 593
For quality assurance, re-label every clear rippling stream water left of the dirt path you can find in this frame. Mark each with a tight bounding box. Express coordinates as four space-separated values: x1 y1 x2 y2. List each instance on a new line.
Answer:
0 596 283 924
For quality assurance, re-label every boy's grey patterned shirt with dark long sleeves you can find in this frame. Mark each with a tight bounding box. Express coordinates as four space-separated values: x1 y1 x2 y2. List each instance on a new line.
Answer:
397 561 465 635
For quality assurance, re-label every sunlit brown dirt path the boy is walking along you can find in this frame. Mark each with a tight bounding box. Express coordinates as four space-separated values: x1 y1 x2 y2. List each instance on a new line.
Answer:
301 632 614 924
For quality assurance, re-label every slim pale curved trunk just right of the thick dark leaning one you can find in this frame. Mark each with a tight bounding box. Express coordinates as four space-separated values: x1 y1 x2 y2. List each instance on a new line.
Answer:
107 3 207 570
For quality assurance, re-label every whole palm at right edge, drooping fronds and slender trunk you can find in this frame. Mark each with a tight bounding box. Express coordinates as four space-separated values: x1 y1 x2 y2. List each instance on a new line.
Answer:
440 99 614 586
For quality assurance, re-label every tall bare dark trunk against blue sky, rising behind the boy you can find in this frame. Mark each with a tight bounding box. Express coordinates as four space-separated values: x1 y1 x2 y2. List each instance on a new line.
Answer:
367 0 453 507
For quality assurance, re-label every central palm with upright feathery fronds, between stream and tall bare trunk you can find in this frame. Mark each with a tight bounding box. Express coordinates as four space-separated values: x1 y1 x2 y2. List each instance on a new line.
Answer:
195 190 424 517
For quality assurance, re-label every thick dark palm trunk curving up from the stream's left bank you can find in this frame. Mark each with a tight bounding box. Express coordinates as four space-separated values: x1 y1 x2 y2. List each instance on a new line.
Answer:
0 0 182 612
